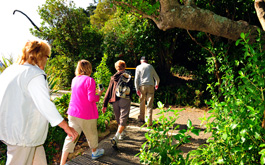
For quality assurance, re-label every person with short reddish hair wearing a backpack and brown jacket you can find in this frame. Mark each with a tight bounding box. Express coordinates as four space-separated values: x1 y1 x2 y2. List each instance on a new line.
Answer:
102 60 133 149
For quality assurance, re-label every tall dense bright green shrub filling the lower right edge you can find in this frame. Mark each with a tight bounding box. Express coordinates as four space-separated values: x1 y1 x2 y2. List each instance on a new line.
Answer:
191 32 265 164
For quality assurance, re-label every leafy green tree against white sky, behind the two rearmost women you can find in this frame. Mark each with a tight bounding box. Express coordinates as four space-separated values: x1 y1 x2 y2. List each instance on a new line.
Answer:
31 0 102 87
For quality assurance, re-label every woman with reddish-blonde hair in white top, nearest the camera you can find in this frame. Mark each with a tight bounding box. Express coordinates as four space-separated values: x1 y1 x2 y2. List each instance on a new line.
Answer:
0 41 78 165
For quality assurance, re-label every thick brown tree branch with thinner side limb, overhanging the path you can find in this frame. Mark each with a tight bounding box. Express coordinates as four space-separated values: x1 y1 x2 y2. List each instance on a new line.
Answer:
114 0 262 41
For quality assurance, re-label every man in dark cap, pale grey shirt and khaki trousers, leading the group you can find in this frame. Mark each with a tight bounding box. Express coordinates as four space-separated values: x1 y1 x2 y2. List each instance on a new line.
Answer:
134 56 160 126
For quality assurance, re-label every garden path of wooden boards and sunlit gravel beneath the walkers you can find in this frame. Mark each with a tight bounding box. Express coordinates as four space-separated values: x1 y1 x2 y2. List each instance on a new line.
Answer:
67 105 210 165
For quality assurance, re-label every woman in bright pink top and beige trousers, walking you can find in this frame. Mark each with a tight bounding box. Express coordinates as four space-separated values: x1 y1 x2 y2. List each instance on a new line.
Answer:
61 60 104 165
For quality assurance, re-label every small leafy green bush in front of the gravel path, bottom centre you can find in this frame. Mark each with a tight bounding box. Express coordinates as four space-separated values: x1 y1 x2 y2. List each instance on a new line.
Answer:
137 102 199 165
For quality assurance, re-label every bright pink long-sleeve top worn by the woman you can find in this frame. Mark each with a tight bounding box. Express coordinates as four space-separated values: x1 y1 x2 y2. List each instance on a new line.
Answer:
67 75 99 120
